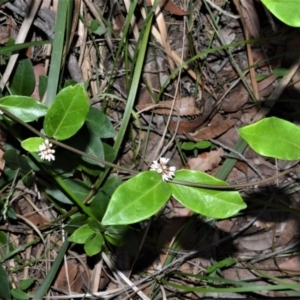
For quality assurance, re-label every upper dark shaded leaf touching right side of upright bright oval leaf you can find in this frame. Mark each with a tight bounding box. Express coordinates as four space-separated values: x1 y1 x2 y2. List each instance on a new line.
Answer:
86 107 116 138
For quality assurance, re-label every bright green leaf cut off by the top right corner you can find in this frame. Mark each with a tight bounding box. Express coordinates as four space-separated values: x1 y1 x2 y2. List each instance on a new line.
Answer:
261 0 300 27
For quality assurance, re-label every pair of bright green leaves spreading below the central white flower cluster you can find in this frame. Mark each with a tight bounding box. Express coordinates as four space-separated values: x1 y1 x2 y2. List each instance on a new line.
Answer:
102 170 246 225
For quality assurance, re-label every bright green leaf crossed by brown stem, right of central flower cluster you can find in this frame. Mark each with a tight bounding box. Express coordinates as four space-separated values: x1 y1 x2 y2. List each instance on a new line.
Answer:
170 170 246 219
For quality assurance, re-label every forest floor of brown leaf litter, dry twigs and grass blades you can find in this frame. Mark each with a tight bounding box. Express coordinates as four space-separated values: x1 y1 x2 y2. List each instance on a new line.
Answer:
0 0 300 299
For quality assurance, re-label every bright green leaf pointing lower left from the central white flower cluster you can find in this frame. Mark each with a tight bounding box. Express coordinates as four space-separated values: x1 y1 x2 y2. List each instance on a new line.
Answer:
102 171 171 225
